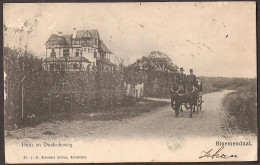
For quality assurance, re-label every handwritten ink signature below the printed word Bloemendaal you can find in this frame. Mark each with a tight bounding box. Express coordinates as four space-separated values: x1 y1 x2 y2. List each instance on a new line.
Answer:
199 146 238 159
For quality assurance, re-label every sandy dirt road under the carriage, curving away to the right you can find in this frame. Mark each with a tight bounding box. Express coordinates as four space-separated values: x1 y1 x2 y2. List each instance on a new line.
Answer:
7 91 230 139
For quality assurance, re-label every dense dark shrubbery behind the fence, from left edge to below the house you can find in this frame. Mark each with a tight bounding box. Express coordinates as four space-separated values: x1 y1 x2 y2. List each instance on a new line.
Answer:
4 48 134 128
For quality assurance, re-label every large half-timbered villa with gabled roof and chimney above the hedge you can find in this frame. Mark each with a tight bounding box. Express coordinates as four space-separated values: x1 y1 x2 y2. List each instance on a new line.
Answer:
44 28 116 72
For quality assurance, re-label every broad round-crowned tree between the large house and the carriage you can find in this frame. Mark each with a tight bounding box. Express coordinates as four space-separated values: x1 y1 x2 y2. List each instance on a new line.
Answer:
124 51 178 96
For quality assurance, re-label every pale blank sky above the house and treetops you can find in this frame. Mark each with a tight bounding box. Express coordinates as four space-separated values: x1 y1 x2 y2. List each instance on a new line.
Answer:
4 2 256 78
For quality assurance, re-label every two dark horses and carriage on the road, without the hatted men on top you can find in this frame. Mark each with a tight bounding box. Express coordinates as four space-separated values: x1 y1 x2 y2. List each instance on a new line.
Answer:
170 80 203 118
